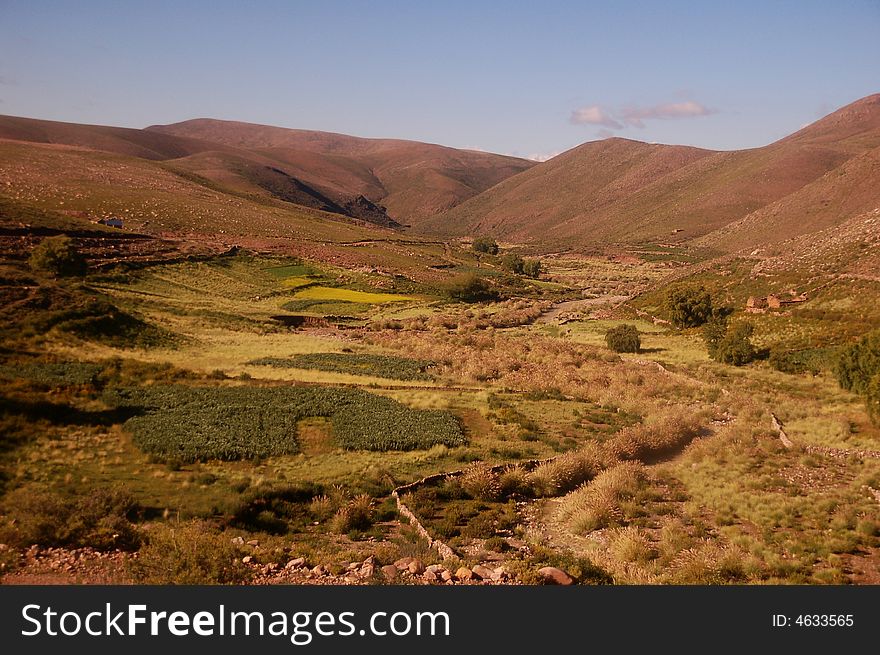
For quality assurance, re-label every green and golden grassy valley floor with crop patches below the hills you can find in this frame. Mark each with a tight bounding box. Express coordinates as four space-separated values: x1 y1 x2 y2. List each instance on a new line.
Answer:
0 242 880 584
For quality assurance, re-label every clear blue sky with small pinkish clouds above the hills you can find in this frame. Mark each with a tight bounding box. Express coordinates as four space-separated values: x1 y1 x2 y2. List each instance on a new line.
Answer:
0 0 880 160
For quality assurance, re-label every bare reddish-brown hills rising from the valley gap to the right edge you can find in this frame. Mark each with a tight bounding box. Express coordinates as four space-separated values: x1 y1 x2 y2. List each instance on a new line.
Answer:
415 95 880 251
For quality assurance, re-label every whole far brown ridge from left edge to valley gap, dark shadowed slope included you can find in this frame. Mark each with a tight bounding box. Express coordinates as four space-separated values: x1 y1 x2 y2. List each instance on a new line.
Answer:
0 116 532 227
